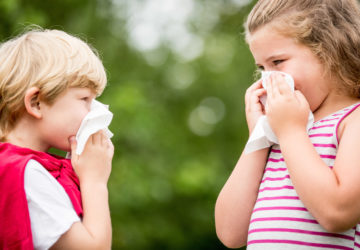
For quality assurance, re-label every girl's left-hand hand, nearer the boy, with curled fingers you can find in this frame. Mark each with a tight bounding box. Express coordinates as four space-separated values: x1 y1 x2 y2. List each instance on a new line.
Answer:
245 80 266 134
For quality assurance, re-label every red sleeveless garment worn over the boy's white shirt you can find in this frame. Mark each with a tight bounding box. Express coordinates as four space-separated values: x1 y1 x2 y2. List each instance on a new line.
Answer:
0 143 83 249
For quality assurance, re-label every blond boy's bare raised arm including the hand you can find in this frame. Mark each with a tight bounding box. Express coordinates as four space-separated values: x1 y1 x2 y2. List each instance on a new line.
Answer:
52 131 114 249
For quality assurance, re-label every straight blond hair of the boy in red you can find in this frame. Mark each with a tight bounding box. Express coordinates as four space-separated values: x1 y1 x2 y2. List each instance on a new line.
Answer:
0 28 107 141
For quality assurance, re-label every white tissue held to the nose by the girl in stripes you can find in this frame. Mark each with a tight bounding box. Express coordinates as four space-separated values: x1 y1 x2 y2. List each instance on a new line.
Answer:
244 71 314 154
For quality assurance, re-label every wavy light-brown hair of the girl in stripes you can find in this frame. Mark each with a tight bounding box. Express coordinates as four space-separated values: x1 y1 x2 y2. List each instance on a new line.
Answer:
245 0 360 97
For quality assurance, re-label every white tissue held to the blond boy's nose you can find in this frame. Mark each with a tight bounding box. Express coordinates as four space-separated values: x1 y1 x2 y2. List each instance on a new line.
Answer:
76 99 113 155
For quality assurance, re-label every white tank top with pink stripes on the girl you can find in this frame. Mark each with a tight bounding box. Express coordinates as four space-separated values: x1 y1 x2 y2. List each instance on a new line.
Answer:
247 103 360 250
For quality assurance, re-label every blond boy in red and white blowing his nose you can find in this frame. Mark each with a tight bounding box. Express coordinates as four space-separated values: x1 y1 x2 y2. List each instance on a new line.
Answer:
0 29 114 249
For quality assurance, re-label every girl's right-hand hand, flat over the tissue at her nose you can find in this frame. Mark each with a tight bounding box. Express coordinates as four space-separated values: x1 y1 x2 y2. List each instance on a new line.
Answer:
265 74 310 140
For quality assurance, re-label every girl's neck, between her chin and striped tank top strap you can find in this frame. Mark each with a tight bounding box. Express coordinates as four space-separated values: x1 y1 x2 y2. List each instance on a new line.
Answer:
313 91 360 121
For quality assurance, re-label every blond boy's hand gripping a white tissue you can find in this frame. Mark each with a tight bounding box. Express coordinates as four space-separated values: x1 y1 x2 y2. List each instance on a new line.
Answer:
70 131 114 183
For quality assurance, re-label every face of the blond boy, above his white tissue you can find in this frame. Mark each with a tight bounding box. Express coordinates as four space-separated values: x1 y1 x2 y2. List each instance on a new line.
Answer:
39 88 95 151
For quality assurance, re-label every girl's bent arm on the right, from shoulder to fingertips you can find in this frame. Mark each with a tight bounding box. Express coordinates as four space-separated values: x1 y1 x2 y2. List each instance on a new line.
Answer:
267 73 360 232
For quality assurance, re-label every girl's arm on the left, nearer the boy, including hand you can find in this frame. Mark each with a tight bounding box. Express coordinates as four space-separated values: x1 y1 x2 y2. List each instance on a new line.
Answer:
215 82 269 248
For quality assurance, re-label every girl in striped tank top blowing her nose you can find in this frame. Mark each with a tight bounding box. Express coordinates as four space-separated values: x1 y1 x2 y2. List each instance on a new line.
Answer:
215 0 360 250
